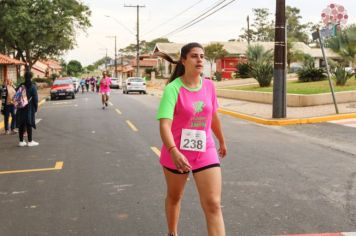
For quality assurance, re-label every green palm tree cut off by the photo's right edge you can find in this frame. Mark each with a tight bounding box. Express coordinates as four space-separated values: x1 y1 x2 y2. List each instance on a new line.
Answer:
327 25 356 68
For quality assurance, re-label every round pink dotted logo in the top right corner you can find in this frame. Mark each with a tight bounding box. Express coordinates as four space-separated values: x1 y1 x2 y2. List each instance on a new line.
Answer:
321 3 349 26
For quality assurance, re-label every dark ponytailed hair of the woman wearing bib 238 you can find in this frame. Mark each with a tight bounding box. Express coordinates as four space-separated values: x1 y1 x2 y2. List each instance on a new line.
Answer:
155 43 204 84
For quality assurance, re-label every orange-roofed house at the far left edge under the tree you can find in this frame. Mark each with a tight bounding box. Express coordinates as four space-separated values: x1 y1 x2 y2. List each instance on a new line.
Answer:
0 54 25 83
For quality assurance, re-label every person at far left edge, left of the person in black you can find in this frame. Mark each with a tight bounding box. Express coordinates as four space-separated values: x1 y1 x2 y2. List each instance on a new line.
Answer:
1 79 17 134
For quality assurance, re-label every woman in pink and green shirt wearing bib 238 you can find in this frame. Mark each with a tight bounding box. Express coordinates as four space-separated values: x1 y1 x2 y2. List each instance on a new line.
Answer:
157 43 227 236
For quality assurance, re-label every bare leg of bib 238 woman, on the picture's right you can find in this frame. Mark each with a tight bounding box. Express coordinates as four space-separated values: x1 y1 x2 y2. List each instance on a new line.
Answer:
194 167 225 236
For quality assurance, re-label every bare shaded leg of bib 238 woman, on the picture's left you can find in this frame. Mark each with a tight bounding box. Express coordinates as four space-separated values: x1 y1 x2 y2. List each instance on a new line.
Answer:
163 168 188 236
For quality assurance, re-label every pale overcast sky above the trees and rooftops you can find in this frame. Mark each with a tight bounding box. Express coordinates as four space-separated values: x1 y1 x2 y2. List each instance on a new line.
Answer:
64 0 356 66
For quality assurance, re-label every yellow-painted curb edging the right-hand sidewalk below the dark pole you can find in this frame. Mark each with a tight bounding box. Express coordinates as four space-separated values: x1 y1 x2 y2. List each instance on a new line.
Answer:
218 108 356 126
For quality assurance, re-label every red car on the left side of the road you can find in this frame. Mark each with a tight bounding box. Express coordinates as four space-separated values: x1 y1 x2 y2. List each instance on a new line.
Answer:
50 78 75 100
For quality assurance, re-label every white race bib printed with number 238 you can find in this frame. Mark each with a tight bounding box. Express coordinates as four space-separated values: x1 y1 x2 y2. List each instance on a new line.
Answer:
180 129 206 152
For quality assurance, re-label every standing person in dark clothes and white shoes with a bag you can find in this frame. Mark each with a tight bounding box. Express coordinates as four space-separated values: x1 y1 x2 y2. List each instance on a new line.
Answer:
16 71 39 147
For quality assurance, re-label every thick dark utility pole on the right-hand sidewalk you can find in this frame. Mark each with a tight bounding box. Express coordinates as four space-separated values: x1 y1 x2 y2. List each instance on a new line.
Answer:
272 0 287 118
